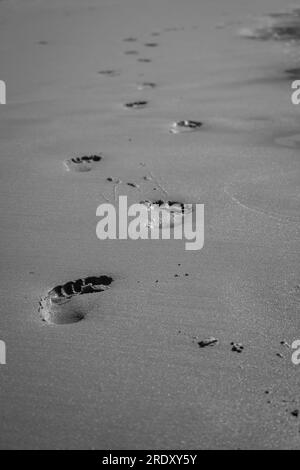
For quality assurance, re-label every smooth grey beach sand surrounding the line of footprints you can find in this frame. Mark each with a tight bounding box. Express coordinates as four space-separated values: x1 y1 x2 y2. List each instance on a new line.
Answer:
0 0 300 449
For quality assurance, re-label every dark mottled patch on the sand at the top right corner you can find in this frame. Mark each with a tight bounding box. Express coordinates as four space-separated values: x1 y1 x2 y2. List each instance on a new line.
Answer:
239 8 300 41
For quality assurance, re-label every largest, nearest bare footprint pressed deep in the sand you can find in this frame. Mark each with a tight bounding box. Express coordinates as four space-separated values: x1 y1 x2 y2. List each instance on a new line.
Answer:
39 276 113 325
